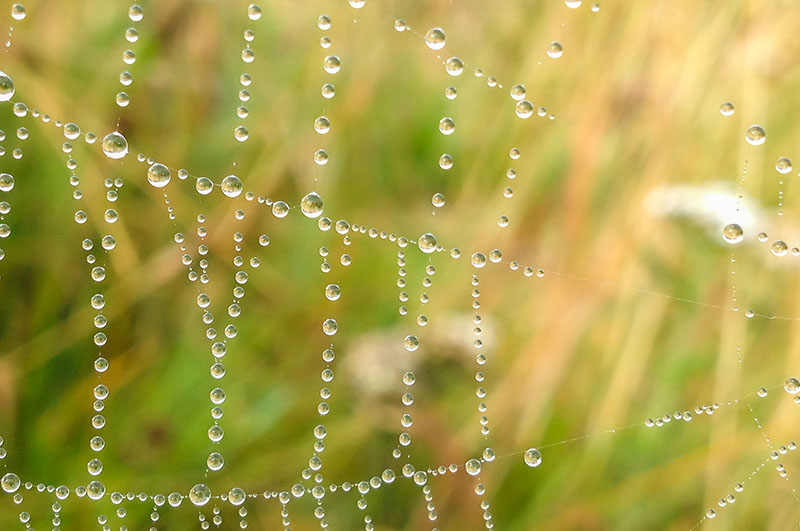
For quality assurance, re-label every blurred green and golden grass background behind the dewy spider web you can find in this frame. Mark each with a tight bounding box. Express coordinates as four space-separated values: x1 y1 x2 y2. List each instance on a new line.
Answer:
0 0 800 530
